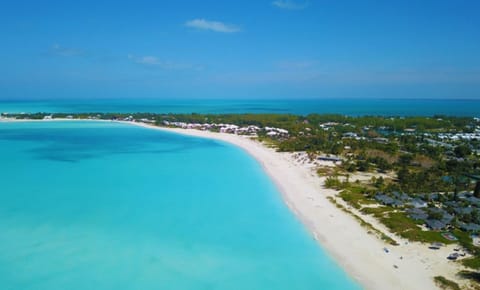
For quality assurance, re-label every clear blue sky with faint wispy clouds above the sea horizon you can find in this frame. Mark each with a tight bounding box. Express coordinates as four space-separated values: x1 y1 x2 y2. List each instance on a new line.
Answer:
0 0 480 99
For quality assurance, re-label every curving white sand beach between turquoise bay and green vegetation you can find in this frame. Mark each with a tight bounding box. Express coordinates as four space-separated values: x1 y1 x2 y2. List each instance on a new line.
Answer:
1 119 464 290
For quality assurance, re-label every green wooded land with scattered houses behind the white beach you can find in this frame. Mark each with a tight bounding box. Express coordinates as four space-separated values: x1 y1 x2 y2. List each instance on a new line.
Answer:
0 113 480 289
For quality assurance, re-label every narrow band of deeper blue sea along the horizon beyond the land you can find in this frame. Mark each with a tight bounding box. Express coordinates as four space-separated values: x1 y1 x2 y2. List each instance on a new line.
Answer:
0 98 480 117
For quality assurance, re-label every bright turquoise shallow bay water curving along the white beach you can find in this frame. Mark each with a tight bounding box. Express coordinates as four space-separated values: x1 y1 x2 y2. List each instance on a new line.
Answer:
0 122 359 290
